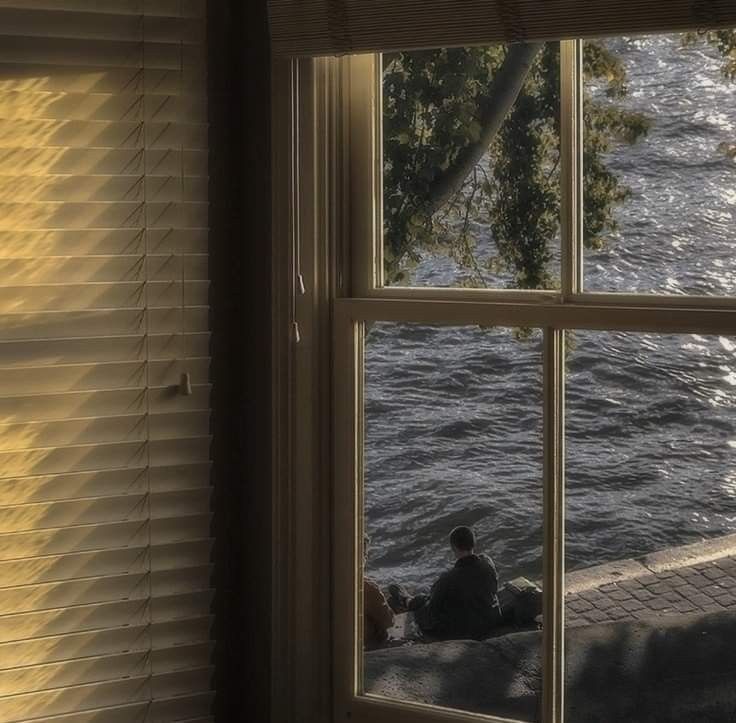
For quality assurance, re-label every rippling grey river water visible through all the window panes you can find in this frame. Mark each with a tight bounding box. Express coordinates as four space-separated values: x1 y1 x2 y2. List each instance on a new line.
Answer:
366 36 736 586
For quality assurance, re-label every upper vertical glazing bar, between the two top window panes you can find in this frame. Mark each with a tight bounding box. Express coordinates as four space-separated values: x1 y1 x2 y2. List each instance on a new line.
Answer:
560 40 583 301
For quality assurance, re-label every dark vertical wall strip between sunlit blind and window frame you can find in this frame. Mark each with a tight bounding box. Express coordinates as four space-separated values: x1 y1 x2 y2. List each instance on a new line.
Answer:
208 0 271 723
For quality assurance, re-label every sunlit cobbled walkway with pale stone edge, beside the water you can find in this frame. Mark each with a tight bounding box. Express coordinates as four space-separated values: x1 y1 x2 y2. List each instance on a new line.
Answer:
565 535 736 627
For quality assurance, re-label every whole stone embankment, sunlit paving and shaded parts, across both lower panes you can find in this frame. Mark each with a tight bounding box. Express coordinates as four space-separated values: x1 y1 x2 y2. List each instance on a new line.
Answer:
365 535 736 723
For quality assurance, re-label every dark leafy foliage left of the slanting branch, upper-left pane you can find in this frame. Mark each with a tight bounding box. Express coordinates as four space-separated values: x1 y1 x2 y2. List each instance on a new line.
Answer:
383 47 503 281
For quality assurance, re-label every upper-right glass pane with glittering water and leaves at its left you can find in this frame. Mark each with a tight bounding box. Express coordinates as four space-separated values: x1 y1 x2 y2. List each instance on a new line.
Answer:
584 30 736 296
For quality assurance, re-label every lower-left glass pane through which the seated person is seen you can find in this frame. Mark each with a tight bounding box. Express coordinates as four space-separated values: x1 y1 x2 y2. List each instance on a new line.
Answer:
363 323 542 721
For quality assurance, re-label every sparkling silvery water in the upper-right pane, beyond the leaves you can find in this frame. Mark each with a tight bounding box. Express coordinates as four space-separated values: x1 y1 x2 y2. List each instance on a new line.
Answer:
585 35 736 296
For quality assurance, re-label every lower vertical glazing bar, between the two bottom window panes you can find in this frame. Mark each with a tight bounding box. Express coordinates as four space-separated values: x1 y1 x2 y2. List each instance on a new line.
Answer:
542 328 565 723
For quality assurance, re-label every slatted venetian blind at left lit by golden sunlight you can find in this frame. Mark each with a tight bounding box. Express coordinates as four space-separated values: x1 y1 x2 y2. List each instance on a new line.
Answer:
0 0 212 723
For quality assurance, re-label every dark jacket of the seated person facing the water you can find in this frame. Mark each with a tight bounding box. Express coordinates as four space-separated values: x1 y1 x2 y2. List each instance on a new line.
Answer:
415 554 500 640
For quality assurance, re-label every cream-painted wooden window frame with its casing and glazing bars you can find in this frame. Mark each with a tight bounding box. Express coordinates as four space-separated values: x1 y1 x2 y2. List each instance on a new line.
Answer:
274 35 736 723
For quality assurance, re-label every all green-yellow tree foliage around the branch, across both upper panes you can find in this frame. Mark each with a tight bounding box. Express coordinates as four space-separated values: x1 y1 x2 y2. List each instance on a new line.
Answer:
384 43 648 288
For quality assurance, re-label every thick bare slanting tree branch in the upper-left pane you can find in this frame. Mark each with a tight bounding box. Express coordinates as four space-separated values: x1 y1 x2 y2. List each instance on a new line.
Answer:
427 43 544 216
